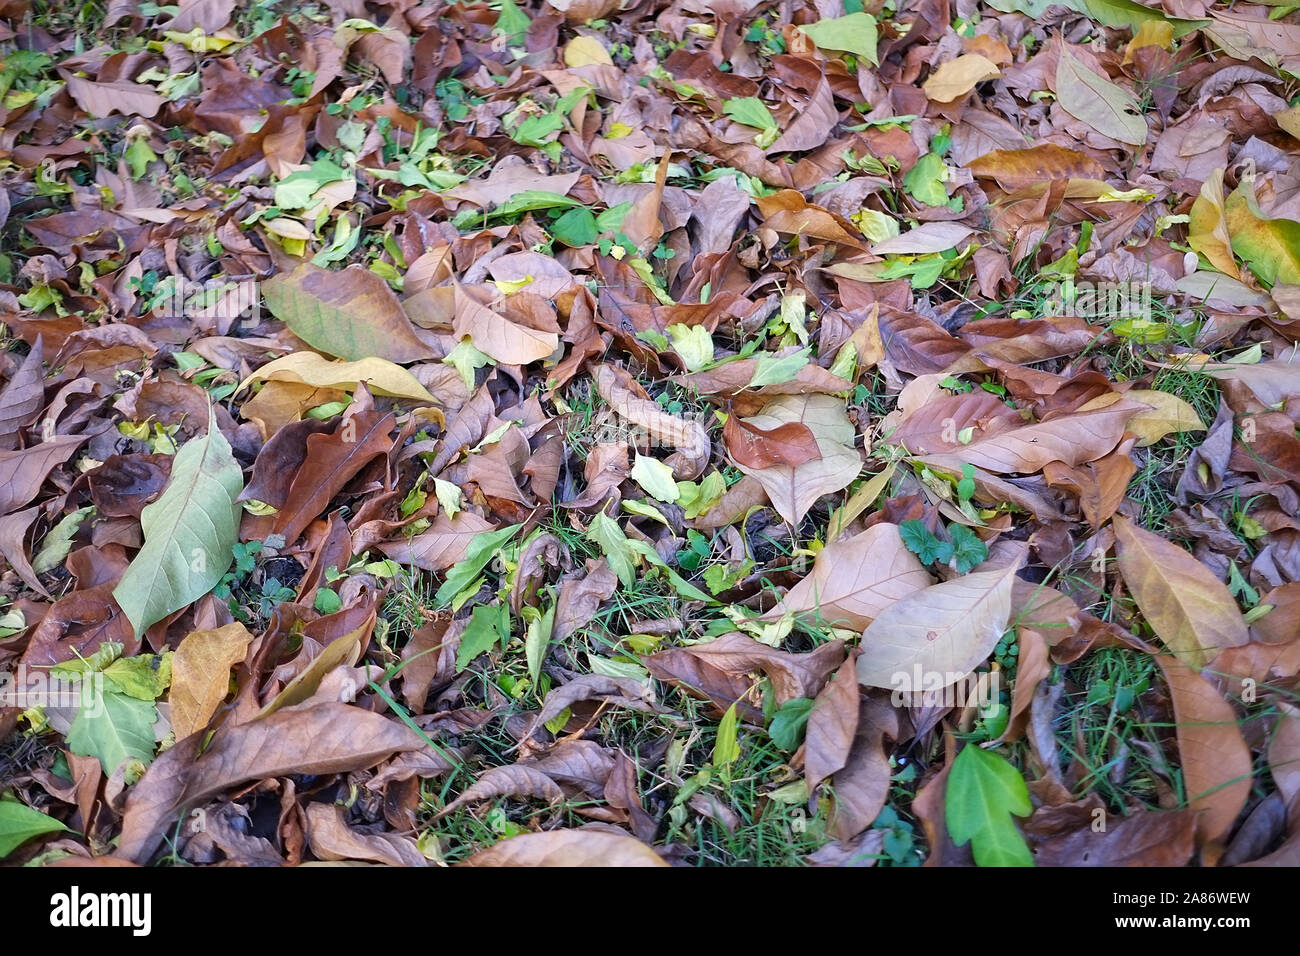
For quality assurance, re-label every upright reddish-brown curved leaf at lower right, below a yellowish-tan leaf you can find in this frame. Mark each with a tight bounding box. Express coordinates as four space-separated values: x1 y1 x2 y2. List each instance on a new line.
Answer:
1156 654 1253 847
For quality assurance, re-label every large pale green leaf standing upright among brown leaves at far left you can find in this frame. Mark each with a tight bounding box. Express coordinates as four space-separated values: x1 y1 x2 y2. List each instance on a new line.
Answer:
113 407 243 637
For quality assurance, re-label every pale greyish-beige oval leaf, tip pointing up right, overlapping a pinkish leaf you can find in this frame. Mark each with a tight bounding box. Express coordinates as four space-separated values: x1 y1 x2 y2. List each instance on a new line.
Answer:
858 564 1015 692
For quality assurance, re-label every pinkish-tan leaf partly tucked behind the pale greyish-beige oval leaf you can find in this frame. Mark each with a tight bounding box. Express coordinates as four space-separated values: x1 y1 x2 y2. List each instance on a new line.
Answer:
763 522 933 631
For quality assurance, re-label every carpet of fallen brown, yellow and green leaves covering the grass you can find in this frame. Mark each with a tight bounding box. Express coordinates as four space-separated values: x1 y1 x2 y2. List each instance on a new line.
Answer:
0 0 1300 865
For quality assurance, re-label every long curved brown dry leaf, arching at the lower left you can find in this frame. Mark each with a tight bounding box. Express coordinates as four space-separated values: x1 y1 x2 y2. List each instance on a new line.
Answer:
116 704 425 864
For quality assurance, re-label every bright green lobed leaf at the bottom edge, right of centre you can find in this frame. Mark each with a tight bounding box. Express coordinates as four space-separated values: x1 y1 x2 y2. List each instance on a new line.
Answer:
945 744 1034 866
